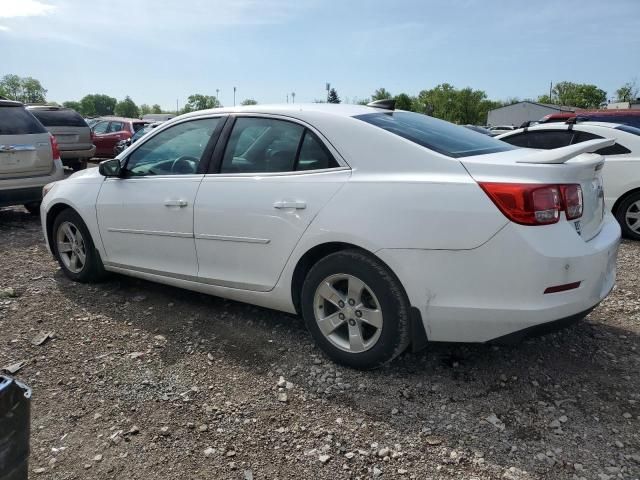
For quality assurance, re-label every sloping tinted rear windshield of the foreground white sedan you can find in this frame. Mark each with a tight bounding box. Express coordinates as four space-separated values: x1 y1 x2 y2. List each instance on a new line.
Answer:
355 112 516 158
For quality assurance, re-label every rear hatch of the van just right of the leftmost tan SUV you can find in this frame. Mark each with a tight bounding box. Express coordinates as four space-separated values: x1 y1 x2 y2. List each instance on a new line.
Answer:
31 109 93 152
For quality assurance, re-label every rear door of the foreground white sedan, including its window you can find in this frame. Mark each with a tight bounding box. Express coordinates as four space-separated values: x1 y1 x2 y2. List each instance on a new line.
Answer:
194 117 350 291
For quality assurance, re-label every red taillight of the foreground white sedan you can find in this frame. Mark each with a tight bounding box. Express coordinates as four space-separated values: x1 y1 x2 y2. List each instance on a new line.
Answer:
480 182 582 225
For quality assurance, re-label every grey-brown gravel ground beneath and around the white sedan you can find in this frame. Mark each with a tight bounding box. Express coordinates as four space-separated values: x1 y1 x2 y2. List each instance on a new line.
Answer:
0 208 640 480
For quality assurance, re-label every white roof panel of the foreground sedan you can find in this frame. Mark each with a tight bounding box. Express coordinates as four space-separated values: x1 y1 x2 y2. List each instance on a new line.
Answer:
178 103 388 120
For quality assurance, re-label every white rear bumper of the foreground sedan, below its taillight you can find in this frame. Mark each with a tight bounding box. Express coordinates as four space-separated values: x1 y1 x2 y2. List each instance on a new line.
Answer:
377 214 620 342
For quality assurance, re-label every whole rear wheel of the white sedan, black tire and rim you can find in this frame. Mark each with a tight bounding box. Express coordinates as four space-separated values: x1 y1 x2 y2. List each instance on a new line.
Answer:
301 250 410 370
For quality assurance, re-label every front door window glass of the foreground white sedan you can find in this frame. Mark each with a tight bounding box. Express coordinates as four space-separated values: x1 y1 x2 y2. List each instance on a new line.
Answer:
126 118 220 176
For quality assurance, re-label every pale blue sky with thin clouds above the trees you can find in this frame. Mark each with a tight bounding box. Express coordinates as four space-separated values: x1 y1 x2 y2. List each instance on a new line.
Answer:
0 0 640 108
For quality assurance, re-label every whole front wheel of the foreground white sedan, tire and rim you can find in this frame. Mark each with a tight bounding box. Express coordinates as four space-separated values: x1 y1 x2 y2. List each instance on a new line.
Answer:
51 208 106 283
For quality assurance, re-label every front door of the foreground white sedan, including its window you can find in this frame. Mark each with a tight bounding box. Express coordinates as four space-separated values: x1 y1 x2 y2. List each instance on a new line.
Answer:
97 118 222 279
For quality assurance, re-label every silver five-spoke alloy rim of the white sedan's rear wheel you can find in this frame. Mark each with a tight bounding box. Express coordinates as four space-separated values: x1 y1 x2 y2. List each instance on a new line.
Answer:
313 273 383 353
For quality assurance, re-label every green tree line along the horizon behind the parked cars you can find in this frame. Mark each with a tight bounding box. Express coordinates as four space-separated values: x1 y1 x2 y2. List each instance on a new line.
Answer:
0 75 640 125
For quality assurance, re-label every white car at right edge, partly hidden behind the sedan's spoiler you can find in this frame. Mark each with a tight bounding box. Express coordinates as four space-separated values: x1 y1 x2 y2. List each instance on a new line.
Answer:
498 122 640 240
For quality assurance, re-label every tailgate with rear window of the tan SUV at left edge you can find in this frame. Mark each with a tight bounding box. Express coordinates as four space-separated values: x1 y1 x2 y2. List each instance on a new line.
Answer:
0 101 53 180
